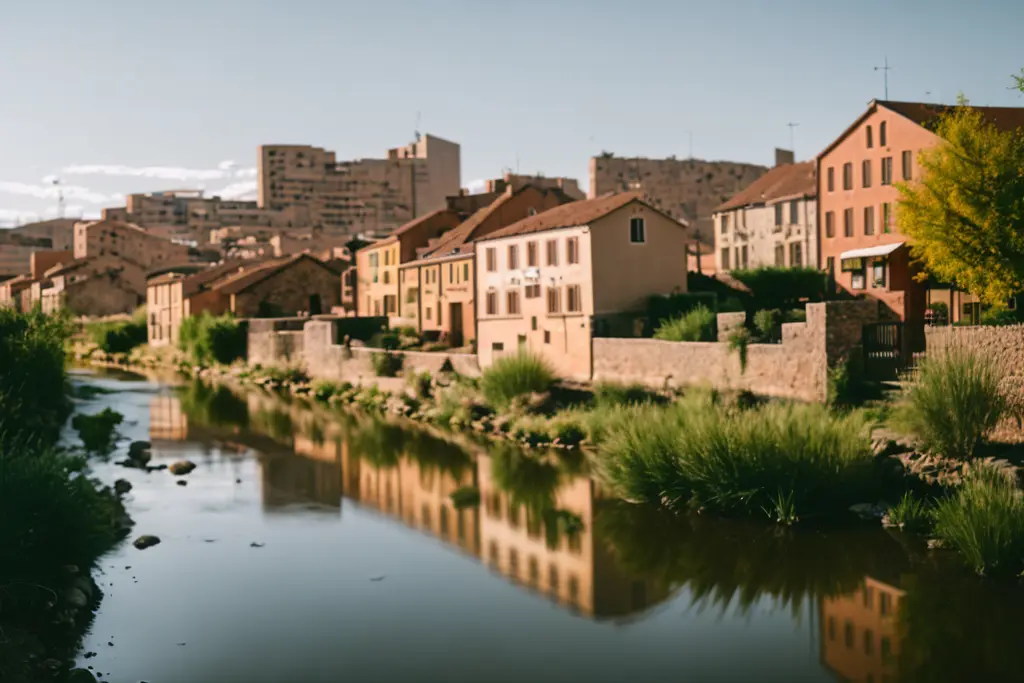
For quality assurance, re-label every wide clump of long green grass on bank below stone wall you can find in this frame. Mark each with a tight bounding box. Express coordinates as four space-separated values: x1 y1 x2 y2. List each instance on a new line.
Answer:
596 394 873 523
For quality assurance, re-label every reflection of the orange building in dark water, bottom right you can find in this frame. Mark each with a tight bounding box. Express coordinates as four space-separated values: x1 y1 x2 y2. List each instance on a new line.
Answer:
821 577 905 683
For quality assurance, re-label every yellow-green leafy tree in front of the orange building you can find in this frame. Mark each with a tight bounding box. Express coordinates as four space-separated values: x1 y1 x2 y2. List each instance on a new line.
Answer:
896 97 1024 305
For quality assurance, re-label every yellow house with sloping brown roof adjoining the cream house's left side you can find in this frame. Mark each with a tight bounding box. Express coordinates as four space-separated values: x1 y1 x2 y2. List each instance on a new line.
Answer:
398 183 575 346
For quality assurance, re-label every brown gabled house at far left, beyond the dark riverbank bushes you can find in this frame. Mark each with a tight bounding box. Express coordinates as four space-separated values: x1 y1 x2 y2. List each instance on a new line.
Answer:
40 255 145 316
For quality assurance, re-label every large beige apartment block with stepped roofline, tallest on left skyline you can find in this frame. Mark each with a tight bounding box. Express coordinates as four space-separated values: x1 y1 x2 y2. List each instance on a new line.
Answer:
257 135 461 239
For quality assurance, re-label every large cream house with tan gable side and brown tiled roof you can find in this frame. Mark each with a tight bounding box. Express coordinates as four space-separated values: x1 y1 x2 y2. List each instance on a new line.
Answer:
475 193 693 380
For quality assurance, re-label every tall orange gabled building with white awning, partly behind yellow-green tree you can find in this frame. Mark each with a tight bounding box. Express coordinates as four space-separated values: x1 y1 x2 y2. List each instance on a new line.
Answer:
817 100 1024 333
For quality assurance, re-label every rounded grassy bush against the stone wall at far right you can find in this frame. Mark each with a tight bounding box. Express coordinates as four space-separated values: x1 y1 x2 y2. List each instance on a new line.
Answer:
893 345 1008 459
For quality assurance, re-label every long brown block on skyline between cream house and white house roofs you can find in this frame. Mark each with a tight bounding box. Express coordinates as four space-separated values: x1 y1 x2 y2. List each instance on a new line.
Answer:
589 154 768 251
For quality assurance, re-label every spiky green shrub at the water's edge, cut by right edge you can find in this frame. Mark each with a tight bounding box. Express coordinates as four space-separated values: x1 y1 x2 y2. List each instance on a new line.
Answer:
935 467 1024 575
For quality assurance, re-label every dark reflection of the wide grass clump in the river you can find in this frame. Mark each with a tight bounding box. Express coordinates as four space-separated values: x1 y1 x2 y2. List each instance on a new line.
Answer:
595 502 905 613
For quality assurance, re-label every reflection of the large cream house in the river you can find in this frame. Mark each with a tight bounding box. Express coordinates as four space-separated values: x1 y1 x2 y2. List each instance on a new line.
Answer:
477 454 668 617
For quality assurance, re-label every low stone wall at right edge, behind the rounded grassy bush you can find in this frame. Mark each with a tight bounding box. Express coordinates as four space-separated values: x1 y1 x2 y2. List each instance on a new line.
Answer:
925 325 1024 442
